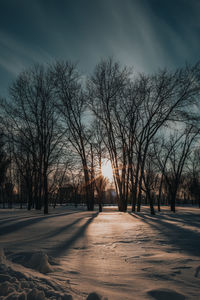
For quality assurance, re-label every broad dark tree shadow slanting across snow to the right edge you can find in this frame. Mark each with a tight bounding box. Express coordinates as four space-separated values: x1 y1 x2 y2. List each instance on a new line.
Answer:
129 213 200 257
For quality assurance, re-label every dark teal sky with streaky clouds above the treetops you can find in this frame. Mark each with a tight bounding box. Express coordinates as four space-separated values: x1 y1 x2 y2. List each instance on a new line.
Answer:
0 0 200 95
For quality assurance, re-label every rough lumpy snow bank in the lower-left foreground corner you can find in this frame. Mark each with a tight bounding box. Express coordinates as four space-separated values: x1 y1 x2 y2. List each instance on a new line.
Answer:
0 249 102 300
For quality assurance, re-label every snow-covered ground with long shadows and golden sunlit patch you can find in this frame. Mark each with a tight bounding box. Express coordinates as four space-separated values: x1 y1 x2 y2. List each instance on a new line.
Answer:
0 207 200 300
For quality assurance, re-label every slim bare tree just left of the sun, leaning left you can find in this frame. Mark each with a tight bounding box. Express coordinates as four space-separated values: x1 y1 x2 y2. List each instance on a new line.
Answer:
51 62 94 210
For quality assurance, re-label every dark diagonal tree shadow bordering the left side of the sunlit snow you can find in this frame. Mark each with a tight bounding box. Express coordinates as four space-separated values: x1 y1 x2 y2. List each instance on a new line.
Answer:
50 212 99 257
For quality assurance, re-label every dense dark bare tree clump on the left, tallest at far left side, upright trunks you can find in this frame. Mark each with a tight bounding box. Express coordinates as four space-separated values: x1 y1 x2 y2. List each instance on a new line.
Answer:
1 65 63 214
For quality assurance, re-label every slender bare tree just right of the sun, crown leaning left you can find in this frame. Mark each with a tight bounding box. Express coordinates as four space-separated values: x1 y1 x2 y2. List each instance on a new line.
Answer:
87 59 130 211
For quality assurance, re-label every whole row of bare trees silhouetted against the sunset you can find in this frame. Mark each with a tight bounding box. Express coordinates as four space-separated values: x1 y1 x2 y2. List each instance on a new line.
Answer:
0 58 200 214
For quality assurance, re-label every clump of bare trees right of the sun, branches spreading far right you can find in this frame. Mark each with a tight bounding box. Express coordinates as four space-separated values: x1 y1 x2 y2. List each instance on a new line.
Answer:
87 59 199 211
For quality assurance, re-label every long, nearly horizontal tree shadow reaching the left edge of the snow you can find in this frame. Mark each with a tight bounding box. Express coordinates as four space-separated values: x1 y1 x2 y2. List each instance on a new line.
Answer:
0 211 83 236
